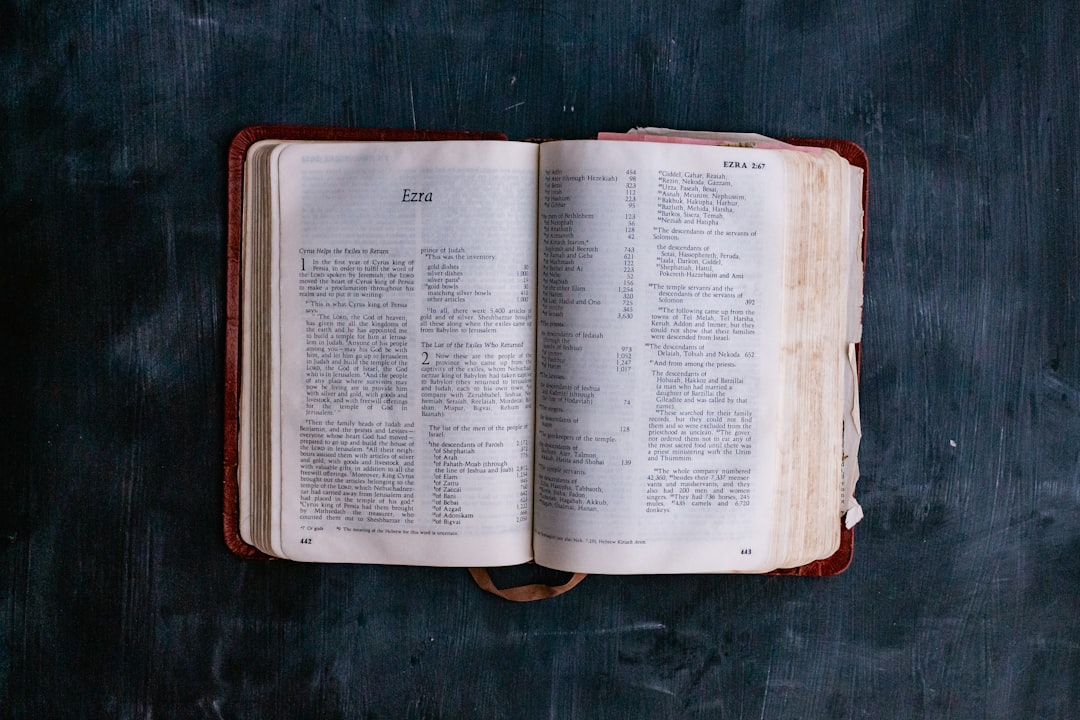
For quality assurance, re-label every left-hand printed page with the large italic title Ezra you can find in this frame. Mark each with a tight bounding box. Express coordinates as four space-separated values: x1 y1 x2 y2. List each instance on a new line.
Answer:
271 140 538 566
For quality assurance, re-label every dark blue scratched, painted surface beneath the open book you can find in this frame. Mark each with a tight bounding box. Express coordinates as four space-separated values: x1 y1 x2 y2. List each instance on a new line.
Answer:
0 0 1080 719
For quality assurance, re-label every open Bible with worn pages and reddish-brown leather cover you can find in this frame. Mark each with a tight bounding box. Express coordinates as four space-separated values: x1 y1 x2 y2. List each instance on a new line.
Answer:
226 128 865 573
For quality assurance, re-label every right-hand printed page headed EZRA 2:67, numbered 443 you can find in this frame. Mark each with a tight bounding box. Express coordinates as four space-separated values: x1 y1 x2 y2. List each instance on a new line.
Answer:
534 141 785 573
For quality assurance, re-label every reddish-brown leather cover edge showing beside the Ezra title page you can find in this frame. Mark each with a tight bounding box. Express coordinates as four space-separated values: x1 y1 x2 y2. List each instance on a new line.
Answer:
221 125 507 558
